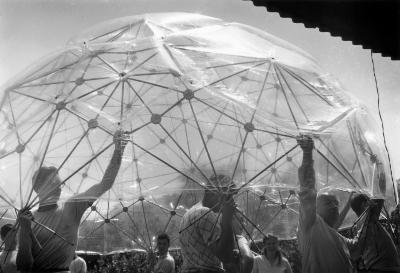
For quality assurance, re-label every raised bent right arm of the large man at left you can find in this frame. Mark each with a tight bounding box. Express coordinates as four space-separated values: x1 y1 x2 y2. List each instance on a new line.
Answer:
66 131 127 215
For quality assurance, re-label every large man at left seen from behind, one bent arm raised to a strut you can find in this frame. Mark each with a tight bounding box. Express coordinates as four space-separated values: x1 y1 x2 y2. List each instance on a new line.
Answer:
17 131 126 272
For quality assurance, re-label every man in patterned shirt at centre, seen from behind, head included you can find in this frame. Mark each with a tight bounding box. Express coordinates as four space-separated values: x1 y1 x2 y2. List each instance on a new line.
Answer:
179 174 237 273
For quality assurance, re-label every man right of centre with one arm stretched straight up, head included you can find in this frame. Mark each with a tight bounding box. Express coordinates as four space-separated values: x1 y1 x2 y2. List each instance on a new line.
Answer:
297 136 353 273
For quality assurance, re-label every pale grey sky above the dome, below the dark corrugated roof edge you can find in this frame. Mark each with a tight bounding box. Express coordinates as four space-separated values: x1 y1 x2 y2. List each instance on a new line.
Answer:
0 0 400 178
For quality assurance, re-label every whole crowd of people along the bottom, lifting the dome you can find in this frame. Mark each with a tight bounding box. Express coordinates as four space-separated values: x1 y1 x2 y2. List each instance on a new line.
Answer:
0 132 400 273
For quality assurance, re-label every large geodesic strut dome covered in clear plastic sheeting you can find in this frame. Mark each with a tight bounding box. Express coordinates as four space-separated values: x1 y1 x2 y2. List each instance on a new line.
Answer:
0 13 395 252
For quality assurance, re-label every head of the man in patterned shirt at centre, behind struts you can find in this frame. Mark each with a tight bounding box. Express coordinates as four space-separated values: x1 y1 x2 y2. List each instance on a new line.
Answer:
203 174 234 212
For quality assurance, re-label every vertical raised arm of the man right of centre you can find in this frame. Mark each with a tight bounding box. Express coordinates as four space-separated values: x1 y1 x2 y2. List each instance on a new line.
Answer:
297 136 317 231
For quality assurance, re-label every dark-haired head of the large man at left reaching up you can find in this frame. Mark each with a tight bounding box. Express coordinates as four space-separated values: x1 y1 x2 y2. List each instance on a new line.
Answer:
32 166 61 200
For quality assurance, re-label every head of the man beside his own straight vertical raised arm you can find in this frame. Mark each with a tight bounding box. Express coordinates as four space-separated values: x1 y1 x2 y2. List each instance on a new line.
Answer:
317 194 339 227
